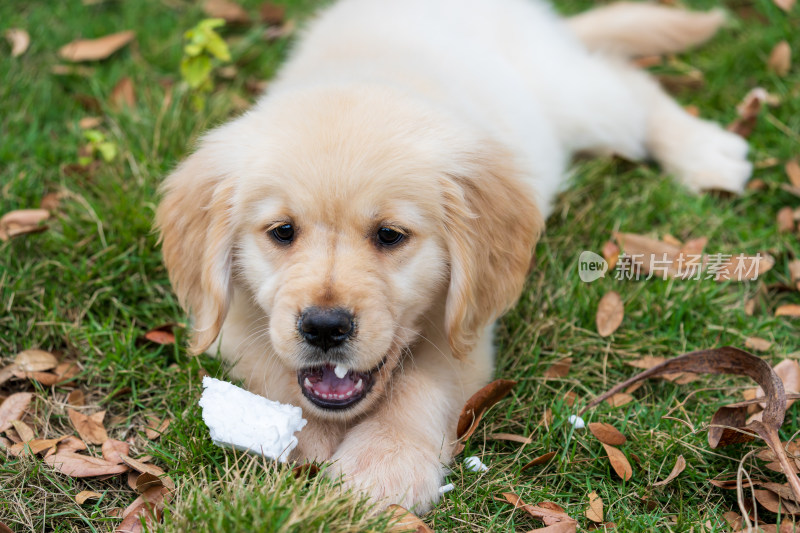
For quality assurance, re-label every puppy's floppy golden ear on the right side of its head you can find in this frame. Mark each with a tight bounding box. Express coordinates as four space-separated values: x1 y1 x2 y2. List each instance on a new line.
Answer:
444 147 544 358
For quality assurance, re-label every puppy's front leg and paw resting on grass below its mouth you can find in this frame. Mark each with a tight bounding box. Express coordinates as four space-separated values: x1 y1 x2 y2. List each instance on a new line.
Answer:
331 353 489 513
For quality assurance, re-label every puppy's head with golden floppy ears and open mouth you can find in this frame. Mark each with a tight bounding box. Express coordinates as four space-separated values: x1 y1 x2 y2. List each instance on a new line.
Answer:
157 88 542 419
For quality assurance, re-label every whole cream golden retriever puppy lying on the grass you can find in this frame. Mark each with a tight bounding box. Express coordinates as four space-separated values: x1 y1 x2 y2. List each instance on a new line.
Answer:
157 0 751 511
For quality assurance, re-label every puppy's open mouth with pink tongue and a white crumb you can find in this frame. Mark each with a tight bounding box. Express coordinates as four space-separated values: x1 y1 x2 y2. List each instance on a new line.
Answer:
297 359 385 409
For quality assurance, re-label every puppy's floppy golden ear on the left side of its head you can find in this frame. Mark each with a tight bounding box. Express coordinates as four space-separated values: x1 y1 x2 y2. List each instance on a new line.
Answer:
156 146 233 354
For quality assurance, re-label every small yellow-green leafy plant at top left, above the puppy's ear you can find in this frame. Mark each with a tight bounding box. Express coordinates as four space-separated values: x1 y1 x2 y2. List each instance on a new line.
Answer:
181 19 231 110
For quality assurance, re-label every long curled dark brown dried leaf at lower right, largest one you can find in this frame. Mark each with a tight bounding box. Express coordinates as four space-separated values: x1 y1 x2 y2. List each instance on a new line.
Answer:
580 348 800 497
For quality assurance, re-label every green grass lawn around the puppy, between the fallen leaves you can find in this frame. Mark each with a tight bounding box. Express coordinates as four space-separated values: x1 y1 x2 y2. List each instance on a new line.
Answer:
0 0 800 532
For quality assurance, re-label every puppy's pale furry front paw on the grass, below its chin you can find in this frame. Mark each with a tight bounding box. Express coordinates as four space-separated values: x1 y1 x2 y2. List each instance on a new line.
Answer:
329 430 444 514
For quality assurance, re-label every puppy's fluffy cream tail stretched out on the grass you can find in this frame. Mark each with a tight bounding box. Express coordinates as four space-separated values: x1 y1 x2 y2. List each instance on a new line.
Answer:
567 2 725 57
